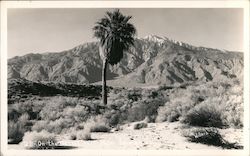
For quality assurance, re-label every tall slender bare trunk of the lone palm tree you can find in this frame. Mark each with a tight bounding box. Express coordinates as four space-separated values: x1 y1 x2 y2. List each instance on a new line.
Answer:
102 59 108 105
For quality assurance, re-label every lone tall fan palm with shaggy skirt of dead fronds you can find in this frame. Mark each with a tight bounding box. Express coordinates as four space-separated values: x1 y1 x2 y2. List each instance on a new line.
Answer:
93 9 136 105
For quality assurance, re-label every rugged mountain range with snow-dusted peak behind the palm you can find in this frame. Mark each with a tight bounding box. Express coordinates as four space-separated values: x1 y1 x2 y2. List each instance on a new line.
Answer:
8 35 243 85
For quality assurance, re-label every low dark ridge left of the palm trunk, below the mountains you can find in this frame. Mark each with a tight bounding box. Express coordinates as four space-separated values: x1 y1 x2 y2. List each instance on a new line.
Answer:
8 78 112 104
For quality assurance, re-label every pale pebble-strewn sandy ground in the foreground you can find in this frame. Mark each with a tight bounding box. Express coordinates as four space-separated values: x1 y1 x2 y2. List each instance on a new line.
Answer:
9 122 243 150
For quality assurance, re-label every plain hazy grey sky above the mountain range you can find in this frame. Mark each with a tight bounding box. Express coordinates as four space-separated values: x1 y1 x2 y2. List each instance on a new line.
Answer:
8 8 243 58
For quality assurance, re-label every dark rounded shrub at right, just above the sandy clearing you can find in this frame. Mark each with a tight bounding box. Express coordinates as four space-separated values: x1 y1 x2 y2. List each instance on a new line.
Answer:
182 100 223 128
